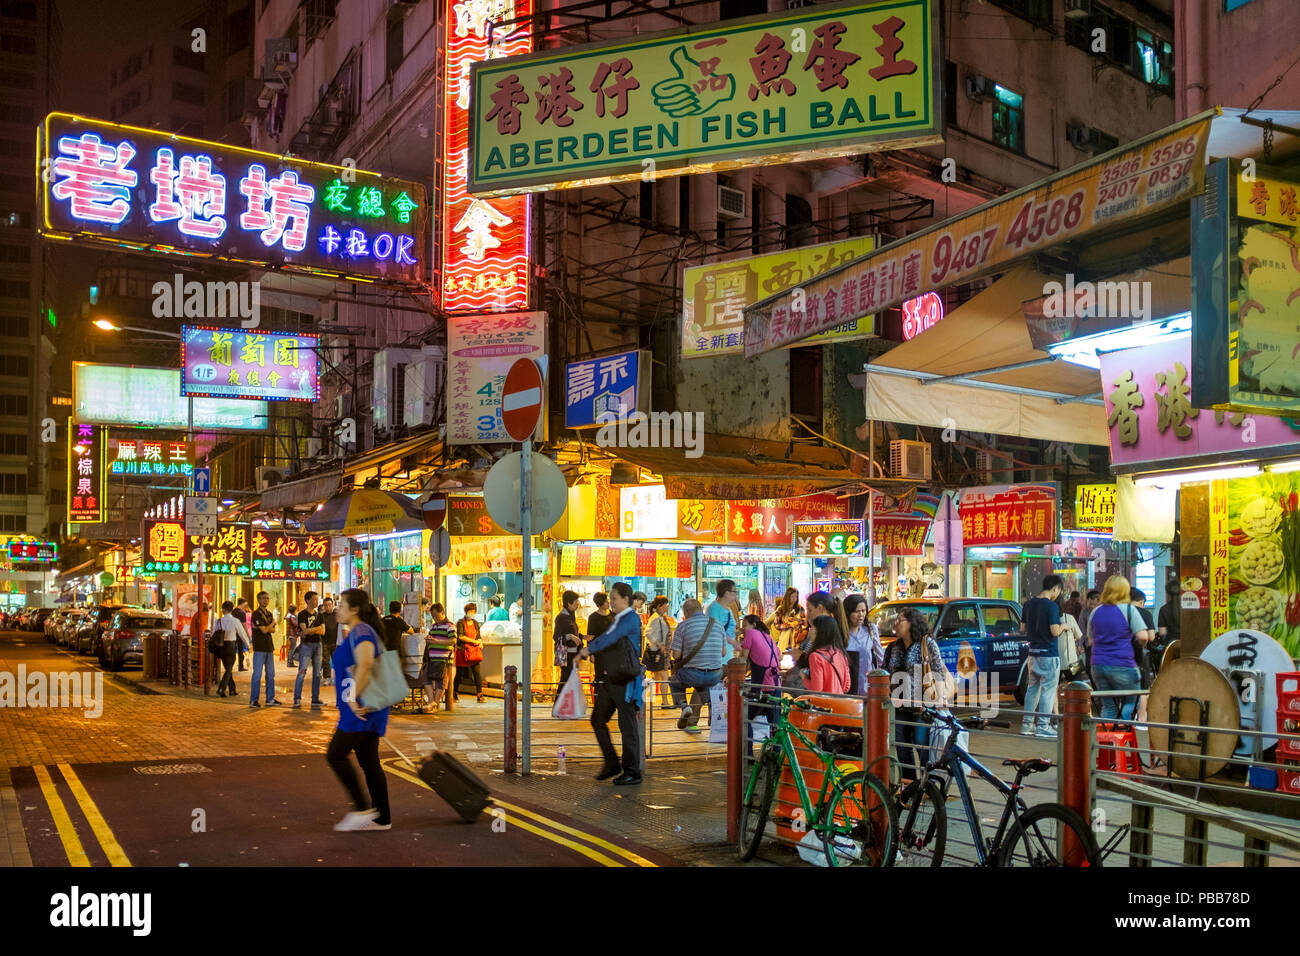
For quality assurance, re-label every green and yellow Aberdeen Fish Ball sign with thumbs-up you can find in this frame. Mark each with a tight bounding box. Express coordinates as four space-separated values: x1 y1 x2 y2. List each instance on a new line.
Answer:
468 0 943 196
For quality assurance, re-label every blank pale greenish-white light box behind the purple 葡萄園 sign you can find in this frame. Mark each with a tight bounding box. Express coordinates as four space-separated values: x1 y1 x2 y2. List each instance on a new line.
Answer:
73 362 268 432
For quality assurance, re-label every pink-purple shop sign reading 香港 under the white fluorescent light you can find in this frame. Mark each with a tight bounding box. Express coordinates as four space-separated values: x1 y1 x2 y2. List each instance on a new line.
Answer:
1101 337 1300 464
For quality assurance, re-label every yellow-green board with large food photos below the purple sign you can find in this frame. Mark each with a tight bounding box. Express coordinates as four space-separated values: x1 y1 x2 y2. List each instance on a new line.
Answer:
1212 472 1300 657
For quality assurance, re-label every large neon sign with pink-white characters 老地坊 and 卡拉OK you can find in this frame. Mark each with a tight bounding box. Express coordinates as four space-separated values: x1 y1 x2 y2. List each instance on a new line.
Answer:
36 113 430 285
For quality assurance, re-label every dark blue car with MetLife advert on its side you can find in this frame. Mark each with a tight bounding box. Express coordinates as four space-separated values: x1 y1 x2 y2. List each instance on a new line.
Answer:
867 597 1030 704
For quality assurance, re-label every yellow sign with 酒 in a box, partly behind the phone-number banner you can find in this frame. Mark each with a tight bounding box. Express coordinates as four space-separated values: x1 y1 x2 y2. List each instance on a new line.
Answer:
681 235 876 359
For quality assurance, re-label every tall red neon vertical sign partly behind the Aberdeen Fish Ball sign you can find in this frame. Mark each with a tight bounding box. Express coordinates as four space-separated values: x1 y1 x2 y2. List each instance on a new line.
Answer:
438 0 533 312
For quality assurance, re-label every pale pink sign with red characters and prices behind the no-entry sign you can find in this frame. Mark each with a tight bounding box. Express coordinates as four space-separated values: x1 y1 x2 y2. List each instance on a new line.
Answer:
447 312 546 447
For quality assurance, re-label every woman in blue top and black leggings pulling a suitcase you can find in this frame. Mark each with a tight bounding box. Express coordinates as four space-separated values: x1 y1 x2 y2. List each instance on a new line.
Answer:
325 588 393 830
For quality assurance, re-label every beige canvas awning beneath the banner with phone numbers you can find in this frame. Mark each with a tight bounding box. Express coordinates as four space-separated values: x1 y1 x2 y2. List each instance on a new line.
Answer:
863 259 1191 445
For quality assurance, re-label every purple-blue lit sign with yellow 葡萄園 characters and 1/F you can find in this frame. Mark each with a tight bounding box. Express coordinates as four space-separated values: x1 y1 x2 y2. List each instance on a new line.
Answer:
181 325 321 402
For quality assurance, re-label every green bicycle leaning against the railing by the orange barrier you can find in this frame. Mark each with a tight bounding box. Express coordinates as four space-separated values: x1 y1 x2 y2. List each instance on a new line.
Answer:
738 695 898 866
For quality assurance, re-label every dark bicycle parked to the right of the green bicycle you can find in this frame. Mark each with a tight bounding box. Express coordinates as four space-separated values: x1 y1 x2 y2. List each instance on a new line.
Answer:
893 708 1110 866
